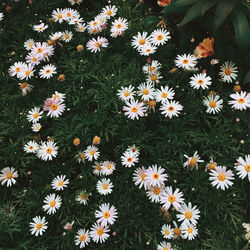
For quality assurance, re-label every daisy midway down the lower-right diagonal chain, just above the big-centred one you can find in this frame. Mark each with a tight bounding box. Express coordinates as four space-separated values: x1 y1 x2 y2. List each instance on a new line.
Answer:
161 186 184 211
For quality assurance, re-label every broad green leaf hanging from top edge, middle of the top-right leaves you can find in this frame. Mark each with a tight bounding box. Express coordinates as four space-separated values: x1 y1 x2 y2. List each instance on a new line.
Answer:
214 0 239 29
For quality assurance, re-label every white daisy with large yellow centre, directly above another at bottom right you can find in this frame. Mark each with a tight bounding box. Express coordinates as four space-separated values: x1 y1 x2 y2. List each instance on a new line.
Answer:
176 202 200 225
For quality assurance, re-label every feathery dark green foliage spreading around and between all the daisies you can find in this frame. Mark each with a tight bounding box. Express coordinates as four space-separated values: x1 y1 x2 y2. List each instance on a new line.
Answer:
0 0 250 250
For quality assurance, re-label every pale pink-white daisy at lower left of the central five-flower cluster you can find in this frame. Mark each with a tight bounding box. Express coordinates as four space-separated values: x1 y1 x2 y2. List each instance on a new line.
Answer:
123 100 146 120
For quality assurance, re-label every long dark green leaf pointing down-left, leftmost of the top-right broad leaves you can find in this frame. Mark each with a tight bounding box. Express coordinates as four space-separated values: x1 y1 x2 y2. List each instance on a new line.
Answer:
179 0 217 27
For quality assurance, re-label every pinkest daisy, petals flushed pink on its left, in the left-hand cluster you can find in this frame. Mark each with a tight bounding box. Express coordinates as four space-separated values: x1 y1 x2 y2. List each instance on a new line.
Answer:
43 98 66 117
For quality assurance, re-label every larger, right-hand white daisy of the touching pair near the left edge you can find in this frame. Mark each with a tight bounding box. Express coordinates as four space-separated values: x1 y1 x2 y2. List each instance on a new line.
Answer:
37 141 58 161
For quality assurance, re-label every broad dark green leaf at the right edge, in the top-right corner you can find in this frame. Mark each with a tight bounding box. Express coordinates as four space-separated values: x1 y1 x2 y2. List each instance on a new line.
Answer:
232 8 249 51
